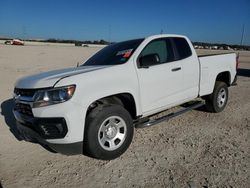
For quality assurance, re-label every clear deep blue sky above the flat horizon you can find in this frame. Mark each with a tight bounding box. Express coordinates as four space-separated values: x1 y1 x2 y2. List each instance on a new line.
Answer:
0 0 250 45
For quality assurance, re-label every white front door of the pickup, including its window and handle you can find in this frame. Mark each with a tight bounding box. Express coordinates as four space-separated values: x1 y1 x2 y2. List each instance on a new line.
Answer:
137 38 184 115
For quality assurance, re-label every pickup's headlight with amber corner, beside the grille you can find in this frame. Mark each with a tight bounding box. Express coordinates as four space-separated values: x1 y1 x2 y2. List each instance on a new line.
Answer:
33 85 76 108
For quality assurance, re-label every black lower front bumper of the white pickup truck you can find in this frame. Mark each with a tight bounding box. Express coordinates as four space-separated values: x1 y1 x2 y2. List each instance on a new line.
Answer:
13 110 83 155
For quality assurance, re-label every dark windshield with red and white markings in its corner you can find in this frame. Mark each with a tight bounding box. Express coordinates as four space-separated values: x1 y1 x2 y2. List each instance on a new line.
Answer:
81 39 144 66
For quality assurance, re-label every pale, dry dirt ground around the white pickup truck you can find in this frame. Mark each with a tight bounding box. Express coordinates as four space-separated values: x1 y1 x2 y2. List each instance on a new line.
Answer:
0 45 250 188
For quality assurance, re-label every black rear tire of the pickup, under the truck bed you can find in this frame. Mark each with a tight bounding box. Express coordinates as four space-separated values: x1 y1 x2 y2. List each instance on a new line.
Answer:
205 81 228 113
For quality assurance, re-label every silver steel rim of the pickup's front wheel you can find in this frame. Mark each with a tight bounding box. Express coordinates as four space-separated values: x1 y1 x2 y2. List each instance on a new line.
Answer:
98 116 127 151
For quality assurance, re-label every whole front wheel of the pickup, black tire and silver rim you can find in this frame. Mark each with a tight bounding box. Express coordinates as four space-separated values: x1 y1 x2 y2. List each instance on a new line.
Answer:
84 105 134 160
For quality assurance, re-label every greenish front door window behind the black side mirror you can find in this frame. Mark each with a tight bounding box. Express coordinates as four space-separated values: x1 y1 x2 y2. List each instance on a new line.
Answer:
140 39 174 63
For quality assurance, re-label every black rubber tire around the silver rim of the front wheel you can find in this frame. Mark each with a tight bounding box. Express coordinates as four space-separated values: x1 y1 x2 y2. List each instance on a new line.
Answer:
83 105 134 160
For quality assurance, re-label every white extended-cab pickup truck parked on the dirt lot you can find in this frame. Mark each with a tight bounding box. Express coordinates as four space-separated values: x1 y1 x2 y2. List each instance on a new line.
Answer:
13 35 238 160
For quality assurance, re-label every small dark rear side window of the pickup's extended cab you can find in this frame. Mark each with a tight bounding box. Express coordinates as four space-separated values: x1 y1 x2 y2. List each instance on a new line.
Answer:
173 37 192 60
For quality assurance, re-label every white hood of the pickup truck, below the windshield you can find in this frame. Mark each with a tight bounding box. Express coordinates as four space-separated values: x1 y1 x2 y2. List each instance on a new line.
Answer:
15 66 109 89
